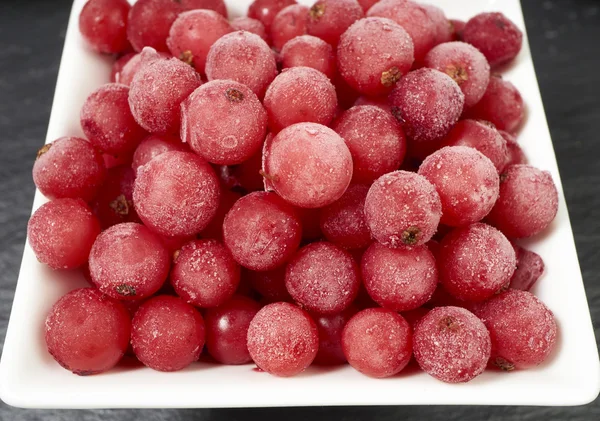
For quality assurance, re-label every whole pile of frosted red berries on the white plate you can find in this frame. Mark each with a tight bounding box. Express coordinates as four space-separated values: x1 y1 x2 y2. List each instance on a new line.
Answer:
28 0 558 383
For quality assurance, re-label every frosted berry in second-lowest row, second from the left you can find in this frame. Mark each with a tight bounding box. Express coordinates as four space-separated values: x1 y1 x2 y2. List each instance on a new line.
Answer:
171 236 240 308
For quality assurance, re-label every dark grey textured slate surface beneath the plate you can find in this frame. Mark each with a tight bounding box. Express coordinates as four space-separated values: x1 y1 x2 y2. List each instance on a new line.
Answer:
0 0 600 421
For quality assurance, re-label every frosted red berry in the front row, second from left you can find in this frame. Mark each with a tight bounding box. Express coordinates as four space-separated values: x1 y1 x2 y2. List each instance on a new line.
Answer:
131 295 205 371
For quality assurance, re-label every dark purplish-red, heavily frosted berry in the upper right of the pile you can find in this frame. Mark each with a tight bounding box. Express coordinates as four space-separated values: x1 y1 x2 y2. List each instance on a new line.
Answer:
389 68 465 148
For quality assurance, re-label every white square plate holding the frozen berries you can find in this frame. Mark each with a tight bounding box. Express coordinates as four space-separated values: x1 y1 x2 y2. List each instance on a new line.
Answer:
0 0 600 408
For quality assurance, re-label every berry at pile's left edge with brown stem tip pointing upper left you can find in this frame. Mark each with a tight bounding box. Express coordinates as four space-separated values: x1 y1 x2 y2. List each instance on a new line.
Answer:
33 137 106 201
